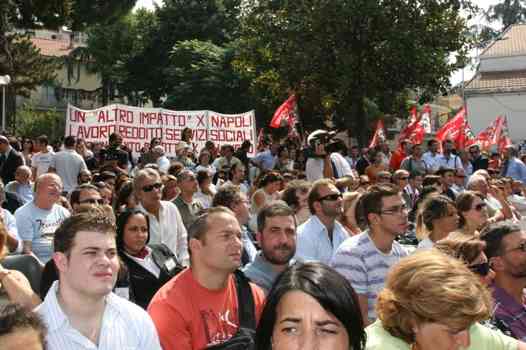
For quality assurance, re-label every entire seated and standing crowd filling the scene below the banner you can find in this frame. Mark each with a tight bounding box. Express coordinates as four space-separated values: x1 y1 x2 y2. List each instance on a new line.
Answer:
0 129 526 350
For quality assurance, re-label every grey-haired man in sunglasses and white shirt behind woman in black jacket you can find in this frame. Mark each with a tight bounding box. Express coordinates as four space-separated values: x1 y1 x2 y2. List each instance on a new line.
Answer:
133 168 190 266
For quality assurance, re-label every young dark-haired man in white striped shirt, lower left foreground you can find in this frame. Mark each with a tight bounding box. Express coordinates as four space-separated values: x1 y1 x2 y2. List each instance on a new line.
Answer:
37 209 161 350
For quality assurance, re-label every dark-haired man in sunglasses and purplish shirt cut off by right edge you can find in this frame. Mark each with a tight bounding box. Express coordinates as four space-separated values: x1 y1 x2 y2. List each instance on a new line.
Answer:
481 223 526 341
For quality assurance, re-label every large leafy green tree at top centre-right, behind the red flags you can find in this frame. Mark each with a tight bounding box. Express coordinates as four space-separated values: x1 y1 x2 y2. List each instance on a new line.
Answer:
236 0 471 143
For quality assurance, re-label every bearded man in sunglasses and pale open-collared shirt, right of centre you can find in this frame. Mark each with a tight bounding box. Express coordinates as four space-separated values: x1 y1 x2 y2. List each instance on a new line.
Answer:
296 179 349 264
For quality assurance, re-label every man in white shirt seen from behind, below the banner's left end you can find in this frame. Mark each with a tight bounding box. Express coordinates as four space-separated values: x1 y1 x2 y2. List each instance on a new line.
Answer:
49 136 88 193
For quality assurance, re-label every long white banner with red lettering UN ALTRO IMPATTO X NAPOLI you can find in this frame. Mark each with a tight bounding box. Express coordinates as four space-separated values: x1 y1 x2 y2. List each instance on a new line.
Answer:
65 104 256 156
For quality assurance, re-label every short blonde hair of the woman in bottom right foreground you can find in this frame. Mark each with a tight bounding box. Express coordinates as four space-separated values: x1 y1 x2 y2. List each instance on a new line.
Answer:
376 250 492 343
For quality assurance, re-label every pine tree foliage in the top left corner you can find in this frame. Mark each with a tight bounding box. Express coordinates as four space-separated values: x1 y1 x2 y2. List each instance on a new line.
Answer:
0 0 136 129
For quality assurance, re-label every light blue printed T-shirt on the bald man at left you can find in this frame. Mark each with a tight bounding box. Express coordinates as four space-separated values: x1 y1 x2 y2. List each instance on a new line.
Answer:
15 202 70 264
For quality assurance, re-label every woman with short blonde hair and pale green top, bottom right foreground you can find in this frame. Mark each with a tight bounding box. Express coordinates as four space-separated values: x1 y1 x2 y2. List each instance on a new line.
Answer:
366 250 526 350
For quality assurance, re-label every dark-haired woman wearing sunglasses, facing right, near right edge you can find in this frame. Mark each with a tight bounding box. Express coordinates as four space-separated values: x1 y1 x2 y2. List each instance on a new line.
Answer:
452 191 488 238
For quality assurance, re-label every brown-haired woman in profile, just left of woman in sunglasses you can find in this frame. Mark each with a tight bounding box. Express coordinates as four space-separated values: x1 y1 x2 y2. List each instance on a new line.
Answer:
416 195 459 249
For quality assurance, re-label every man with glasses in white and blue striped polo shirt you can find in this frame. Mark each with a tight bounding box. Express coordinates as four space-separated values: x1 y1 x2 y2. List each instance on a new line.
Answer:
331 184 408 325
